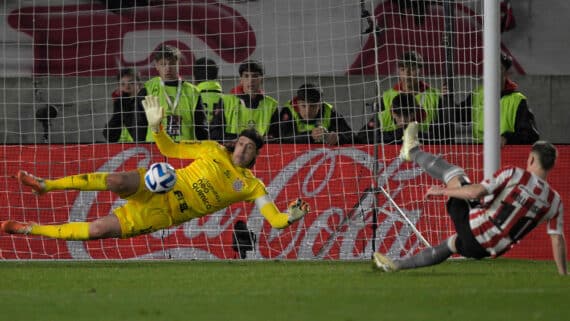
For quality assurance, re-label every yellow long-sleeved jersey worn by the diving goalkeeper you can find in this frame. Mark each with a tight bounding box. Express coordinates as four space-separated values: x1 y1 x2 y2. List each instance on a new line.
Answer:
154 130 267 217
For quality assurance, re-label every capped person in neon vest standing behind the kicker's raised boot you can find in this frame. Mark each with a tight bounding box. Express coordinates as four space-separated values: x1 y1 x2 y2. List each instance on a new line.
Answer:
360 51 451 144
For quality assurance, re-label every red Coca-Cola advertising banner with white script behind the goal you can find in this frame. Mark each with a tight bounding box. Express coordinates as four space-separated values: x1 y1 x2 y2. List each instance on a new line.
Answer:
0 144 570 259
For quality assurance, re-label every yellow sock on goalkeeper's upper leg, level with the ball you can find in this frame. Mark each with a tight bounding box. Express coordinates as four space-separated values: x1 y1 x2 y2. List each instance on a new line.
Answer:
44 173 109 192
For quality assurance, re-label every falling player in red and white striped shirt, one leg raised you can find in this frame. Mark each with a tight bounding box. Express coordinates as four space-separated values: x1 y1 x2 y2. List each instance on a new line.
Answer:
373 123 568 275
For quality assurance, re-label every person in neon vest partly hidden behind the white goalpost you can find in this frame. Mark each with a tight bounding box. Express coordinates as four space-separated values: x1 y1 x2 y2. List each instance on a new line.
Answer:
457 53 540 146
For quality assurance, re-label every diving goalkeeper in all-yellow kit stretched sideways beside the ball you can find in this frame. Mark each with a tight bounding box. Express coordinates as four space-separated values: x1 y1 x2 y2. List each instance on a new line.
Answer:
1 96 310 240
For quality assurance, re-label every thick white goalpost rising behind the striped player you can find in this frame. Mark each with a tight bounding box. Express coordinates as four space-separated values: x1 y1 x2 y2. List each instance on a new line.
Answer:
483 0 501 178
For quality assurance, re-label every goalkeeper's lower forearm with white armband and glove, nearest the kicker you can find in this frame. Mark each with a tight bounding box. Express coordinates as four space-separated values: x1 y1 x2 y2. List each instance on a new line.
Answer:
255 195 311 229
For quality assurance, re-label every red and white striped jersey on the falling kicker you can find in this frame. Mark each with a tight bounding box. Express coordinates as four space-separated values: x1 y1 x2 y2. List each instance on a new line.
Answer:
469 167 563 256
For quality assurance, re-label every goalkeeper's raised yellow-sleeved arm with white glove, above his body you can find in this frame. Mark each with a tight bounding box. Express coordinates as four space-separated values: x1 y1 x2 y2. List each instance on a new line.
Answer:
142 96 212 159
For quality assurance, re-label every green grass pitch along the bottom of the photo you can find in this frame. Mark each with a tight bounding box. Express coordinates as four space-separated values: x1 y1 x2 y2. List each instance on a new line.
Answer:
0 259 570 321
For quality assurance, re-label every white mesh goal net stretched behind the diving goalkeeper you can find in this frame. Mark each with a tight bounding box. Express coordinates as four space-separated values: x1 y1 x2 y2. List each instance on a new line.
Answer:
0 0 490 259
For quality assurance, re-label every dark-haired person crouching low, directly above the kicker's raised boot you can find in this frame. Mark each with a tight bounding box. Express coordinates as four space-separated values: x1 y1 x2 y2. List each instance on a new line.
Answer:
357 93 426 144
